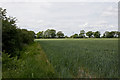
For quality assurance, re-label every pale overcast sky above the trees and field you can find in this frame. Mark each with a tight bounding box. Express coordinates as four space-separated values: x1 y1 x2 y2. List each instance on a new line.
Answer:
0 0 118 36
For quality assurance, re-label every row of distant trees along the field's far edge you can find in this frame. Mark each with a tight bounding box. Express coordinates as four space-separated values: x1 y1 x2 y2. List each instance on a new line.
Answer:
36 29 120 39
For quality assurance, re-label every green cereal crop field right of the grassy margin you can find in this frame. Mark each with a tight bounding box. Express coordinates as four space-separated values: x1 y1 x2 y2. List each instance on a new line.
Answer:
35 39 118 78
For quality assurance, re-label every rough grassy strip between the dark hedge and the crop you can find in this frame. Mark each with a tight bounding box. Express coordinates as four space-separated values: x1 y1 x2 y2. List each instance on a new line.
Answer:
2 43 56 78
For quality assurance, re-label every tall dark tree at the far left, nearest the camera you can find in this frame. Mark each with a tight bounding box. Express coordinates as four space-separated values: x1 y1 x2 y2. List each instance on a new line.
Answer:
2 10 19 53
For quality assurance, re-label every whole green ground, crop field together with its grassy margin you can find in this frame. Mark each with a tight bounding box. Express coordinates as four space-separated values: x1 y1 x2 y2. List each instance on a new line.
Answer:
2 39 118 78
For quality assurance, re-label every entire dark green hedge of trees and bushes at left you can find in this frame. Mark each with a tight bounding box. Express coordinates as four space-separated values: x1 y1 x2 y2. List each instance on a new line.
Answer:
2 9 35 57
